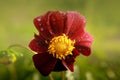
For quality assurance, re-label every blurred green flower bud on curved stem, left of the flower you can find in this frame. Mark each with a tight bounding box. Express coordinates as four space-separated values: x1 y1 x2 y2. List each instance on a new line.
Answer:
0 45 33 65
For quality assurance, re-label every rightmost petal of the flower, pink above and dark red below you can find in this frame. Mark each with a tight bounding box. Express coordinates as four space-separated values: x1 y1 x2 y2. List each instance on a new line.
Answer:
75 32 93 56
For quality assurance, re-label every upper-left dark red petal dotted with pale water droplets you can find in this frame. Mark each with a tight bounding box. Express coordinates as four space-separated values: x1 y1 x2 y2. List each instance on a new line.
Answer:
34 11 53 40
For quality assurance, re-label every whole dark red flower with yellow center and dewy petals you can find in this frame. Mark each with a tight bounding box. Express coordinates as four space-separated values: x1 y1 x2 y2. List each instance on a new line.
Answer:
29 11 93 76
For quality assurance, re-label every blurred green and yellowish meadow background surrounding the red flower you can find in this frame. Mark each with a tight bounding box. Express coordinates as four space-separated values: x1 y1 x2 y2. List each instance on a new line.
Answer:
0 0 120 80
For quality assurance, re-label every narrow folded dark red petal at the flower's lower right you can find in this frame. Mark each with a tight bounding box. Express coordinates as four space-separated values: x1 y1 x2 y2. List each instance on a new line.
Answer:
62 49 79 72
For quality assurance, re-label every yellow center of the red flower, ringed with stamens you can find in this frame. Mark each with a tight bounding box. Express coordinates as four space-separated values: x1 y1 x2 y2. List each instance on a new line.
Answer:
48 34 75 59
